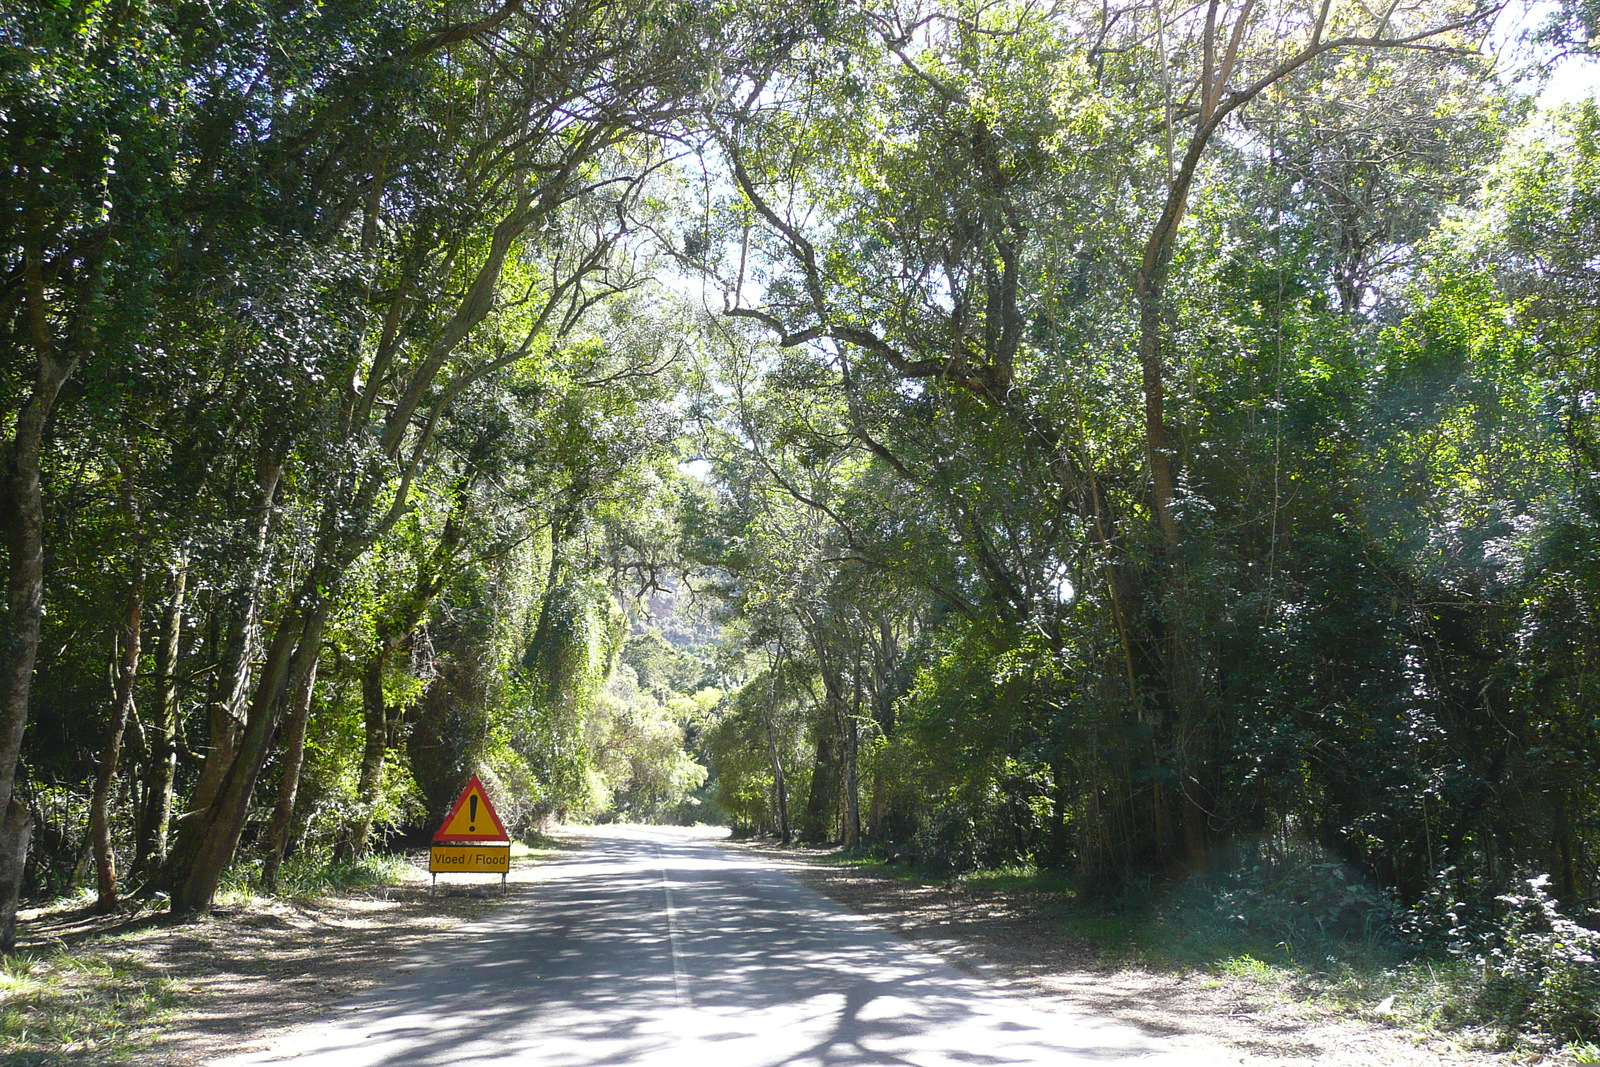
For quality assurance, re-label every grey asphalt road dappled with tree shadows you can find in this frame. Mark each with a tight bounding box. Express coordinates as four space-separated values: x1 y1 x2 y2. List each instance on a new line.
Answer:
216 829 1238 1067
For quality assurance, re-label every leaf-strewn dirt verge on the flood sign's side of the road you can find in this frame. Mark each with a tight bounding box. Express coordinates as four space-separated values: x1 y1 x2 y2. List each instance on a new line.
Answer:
0 840 581 1067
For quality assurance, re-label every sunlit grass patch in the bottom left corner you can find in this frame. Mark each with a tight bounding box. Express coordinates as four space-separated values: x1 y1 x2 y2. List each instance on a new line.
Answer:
0 942 181 1067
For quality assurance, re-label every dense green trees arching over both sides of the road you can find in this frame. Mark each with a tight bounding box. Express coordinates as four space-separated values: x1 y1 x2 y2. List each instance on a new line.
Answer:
0 0 1600 1035
